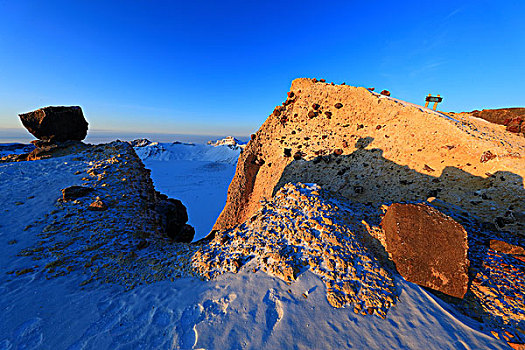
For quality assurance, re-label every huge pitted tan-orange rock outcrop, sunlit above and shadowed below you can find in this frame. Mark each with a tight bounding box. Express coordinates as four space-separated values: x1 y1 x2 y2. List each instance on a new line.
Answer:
214 79 525 237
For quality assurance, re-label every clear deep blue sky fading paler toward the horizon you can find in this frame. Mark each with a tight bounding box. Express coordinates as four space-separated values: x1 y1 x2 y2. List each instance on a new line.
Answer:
0 0 525 135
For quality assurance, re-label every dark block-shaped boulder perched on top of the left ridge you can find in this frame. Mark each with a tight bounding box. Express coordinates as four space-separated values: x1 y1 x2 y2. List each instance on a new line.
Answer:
19 106 88 141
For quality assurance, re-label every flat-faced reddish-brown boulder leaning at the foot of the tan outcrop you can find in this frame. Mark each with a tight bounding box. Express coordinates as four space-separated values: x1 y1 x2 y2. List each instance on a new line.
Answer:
381 203 469 298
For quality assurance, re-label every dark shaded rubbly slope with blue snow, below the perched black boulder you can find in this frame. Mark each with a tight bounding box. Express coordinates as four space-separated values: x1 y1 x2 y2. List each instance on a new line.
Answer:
8 142 196 288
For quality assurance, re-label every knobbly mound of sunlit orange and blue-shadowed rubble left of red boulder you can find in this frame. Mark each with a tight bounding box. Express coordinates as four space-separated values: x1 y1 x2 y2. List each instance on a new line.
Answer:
193 183 397 318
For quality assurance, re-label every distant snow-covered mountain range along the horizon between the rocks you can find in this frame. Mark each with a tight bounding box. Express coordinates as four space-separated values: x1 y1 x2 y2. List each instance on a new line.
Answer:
132 140 242 164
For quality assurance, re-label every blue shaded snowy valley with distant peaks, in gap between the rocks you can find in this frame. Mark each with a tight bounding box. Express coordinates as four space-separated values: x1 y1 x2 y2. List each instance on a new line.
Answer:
135 139 242 240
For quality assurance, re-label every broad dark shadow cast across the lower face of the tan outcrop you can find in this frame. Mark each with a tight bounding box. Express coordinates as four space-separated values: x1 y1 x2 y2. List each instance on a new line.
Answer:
272 137 525 240
